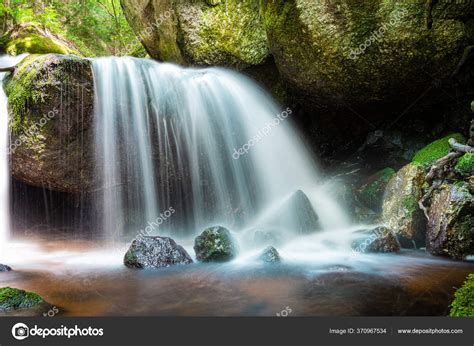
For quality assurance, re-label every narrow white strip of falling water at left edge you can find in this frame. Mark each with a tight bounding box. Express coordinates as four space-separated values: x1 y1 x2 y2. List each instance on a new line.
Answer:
0 55 25 247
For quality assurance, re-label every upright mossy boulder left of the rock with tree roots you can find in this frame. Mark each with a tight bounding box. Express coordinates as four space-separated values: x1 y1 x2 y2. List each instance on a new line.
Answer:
382 163 426 246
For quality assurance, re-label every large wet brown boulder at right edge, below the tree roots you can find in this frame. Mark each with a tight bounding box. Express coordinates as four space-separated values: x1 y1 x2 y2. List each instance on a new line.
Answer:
426 183 474 259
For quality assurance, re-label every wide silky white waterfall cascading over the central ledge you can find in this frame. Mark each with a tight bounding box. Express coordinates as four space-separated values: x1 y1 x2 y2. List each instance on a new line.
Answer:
93 58 347 243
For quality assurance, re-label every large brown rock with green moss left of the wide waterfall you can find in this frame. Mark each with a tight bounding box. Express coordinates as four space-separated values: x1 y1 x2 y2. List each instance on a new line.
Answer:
4 54 94 192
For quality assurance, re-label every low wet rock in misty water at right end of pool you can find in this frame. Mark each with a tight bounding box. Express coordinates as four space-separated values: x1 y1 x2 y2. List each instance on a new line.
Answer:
351 227 400 253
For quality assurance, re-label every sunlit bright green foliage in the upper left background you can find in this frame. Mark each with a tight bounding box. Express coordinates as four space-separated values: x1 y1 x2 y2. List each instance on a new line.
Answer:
0 0 139 56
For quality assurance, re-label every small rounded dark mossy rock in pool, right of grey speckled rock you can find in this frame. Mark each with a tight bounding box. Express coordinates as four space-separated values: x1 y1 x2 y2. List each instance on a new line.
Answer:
194 226 237 262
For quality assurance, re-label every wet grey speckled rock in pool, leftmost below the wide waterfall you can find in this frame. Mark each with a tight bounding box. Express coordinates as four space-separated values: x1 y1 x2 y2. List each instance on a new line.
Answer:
124 236 193 269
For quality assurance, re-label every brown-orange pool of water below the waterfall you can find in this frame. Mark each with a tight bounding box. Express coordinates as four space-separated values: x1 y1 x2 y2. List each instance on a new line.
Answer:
0 241 474 316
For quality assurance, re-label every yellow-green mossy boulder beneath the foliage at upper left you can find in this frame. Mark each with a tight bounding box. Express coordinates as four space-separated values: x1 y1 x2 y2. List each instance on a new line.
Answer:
0 24 80 55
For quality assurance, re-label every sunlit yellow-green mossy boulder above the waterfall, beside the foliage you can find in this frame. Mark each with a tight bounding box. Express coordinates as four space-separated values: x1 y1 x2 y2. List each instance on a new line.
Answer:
121 0 269 67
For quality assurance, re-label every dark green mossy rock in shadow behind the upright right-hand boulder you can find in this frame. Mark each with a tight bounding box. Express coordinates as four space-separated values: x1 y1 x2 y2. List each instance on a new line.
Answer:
358 168 396 212
